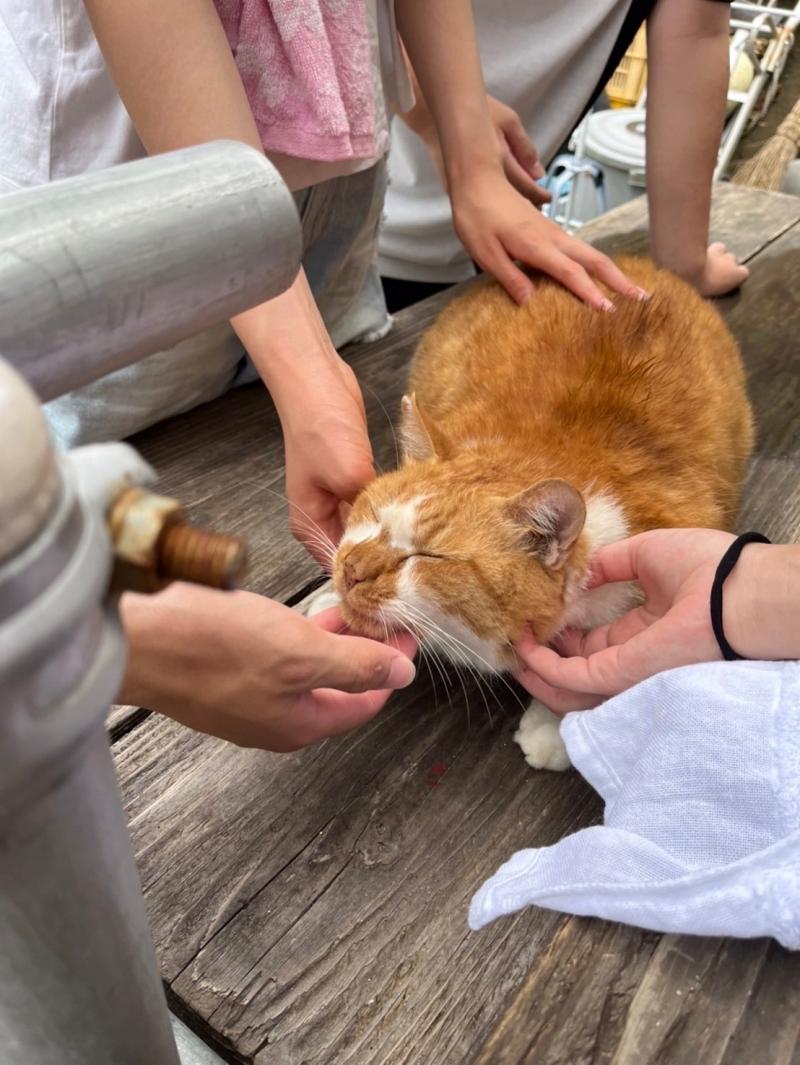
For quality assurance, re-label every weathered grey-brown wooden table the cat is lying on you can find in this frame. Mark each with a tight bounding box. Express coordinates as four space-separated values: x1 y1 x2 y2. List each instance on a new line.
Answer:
112 186 800 1065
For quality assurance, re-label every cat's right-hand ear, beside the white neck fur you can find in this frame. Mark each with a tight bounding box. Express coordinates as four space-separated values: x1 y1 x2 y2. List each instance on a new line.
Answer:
506 478 586 570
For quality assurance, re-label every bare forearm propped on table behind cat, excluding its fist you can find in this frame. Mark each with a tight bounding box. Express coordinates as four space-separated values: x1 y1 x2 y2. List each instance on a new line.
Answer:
647 0 729 281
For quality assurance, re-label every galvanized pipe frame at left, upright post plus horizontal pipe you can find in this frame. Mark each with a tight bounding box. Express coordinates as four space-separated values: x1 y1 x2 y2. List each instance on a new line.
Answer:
0 145 299 1065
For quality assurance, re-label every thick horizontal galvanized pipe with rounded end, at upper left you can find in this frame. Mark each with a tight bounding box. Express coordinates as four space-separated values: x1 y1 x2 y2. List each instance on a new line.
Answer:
0 142 300 400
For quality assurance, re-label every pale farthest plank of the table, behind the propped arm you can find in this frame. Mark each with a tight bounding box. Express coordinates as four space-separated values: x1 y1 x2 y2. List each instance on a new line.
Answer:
581 183 800 262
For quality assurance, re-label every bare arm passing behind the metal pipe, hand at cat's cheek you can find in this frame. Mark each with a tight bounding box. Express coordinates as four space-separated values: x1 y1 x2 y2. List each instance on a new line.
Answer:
85 0 373 561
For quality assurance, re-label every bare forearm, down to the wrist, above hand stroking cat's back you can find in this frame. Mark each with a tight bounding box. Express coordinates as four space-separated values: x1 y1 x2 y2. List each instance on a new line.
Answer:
396 0 502 187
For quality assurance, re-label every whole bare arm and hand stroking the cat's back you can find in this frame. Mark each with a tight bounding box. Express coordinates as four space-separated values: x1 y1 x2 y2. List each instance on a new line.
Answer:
396 0 640 310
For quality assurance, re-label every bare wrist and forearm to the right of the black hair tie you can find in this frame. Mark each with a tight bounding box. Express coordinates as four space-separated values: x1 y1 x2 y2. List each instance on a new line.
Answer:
722 544 800 659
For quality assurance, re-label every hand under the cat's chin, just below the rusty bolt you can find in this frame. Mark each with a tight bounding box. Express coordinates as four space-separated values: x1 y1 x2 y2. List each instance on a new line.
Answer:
119 584 417 751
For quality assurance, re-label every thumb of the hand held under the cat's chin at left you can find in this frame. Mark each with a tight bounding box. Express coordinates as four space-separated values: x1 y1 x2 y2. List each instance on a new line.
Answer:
314 632 417 692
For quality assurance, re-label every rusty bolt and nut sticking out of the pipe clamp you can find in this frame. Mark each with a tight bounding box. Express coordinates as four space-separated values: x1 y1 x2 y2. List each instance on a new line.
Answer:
108 488 247 592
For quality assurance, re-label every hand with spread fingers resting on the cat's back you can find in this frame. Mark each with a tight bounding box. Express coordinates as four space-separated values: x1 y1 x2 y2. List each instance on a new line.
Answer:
451 167 647 311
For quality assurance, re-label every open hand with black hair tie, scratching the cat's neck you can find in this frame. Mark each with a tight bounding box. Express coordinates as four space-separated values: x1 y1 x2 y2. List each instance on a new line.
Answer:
516 529 737 714
